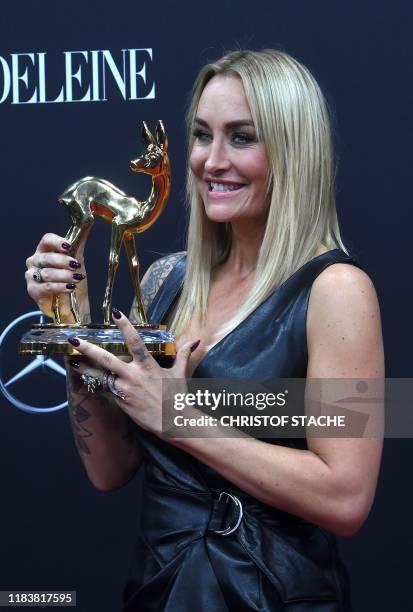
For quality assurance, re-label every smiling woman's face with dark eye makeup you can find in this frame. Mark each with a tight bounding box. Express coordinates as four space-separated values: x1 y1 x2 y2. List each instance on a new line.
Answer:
190 75 269 223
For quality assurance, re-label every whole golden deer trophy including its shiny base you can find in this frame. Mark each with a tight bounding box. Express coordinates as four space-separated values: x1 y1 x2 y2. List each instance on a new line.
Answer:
20 121 176 363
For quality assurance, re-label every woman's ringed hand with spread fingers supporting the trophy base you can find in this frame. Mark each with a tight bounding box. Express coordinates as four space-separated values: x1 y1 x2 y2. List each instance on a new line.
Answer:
69 308 199 436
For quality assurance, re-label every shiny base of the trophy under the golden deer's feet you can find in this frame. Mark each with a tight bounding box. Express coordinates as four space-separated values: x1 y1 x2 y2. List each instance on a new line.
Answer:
19 323 176 360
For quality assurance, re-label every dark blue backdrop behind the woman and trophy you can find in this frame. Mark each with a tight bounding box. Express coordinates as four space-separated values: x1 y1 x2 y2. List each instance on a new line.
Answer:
0 0 413 612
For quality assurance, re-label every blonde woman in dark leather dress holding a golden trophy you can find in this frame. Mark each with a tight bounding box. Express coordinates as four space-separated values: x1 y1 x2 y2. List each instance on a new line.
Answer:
27 50 384 612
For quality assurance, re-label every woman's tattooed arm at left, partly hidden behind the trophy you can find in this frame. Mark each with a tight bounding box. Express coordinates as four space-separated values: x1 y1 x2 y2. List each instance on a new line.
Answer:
66 254 179 491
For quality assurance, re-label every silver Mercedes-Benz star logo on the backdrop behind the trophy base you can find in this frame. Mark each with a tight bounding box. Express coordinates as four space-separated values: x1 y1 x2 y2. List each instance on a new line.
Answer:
0 310 67 414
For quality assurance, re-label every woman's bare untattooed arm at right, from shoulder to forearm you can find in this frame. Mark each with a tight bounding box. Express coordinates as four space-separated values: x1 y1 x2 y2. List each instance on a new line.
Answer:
166 264 384 535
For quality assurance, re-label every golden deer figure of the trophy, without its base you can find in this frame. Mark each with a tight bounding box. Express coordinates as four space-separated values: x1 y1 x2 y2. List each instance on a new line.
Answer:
53 121 171 325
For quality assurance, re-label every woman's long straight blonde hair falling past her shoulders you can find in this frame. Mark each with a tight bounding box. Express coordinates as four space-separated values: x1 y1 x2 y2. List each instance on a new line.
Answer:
167 49 346 341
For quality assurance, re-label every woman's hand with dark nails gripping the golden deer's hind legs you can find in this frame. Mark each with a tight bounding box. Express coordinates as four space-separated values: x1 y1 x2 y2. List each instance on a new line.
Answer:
25 234 90 323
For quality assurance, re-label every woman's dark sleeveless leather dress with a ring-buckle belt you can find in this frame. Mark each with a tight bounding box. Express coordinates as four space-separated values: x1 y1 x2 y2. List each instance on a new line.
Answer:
124 249 357 612
